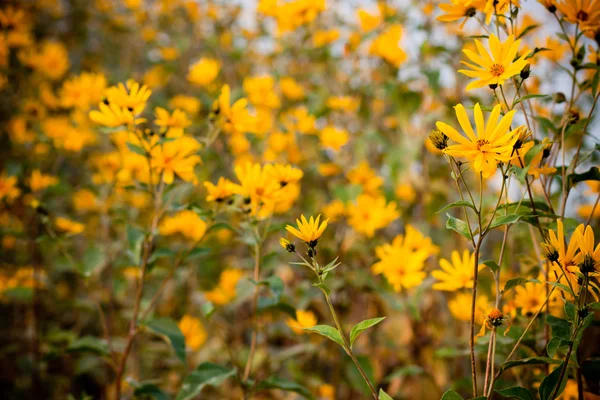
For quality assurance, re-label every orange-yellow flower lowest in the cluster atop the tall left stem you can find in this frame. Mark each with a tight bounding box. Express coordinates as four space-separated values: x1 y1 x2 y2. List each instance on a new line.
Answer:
151 136 202 184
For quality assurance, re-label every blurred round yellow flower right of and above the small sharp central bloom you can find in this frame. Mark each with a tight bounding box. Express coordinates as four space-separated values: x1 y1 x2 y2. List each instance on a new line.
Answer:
348 194 400 238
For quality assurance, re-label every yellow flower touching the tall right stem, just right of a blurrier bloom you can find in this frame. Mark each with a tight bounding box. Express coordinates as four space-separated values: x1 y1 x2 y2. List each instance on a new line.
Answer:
431 250 481 292
